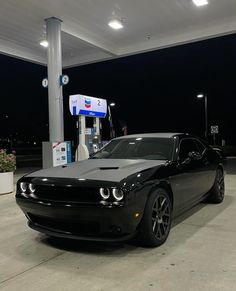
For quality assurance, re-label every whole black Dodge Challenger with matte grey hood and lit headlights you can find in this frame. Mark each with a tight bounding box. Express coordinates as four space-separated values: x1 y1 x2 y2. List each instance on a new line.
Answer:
16 133 224 246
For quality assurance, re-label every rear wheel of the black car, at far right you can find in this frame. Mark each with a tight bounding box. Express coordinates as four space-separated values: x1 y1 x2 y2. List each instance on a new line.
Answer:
207 169 225 203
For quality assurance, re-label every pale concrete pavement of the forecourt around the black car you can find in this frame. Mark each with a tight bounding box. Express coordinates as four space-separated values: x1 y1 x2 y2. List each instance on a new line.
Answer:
0 158 236 291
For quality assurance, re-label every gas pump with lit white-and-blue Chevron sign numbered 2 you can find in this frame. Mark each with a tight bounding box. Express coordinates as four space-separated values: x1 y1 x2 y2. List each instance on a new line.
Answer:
69 94 107 161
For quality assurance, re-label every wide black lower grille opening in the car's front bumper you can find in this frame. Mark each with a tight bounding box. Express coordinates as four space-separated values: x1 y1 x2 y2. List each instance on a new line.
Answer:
27 213 100 236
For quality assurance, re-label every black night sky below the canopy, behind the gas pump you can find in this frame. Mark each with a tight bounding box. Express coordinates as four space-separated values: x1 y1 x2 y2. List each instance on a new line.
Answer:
0 35 236 144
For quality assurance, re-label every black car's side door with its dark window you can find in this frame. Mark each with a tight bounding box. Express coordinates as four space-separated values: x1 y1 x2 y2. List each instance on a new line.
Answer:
172 138 205 208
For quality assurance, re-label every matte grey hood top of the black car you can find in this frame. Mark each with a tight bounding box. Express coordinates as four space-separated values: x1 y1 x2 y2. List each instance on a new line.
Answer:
27 159 166 182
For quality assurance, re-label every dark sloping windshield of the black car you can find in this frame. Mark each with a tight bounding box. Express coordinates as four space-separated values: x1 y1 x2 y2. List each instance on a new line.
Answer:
91 137 174 160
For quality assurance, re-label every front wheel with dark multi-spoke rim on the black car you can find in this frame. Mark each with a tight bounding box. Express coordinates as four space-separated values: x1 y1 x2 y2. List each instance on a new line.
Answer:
138 188 172 247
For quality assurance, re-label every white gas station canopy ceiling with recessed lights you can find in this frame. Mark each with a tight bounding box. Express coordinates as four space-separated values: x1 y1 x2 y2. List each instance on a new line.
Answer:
0 0 236 67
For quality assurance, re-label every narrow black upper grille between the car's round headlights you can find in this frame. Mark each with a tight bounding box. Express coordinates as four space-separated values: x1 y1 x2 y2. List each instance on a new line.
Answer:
34 185 101 203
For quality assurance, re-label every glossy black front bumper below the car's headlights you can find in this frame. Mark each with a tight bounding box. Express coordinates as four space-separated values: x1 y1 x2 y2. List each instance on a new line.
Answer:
16 194 141 242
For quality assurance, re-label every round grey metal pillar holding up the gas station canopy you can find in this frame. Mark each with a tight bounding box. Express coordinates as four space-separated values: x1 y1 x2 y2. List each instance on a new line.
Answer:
45 17 64 142
